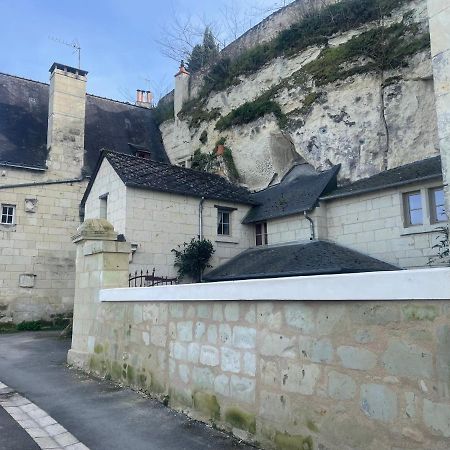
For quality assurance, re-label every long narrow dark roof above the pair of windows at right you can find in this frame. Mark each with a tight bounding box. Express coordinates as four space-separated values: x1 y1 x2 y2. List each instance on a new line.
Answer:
321 156 442 200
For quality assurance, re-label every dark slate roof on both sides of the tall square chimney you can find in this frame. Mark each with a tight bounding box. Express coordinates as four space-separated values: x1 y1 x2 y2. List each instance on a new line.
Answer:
0 73 168 175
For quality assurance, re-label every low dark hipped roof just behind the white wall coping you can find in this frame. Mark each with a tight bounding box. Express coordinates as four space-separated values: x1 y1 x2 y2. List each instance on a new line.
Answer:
204 241 398 281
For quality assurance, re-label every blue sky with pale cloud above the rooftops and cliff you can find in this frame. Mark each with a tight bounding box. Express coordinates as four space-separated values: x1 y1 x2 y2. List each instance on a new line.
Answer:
0 0 290 101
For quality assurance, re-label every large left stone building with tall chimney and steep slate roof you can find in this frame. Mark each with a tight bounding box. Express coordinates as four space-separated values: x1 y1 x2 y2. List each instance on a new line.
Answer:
0 64 167 323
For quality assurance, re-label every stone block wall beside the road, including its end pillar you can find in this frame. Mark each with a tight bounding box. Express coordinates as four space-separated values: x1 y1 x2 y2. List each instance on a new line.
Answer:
69 221 450 450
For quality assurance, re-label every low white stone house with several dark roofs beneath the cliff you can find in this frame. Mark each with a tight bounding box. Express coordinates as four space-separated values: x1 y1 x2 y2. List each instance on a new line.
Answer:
82 152 447 281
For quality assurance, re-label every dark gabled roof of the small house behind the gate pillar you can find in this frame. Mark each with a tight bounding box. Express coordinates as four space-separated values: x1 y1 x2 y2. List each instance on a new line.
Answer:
81 151 255 205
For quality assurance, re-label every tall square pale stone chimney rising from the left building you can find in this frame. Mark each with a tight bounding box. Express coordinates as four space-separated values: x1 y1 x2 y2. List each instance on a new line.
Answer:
47 63 87 178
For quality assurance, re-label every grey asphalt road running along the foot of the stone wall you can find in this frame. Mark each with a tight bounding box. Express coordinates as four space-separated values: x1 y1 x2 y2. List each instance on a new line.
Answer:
0 332 253 450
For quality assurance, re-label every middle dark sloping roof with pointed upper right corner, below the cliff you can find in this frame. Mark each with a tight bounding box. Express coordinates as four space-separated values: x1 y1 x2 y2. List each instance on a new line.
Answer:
244 166 340 223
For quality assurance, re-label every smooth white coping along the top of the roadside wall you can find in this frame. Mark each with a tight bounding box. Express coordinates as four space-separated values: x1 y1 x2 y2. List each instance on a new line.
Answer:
99 268 450 302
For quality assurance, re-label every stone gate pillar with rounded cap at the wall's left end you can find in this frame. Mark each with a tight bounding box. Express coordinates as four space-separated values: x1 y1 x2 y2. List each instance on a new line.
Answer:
67 219 131 369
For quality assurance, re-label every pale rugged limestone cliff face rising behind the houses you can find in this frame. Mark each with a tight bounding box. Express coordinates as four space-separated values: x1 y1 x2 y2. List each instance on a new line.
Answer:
161 0 438 189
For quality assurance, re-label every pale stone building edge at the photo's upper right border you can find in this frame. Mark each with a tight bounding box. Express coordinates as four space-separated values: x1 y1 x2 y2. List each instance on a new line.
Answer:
427 0 450 217
